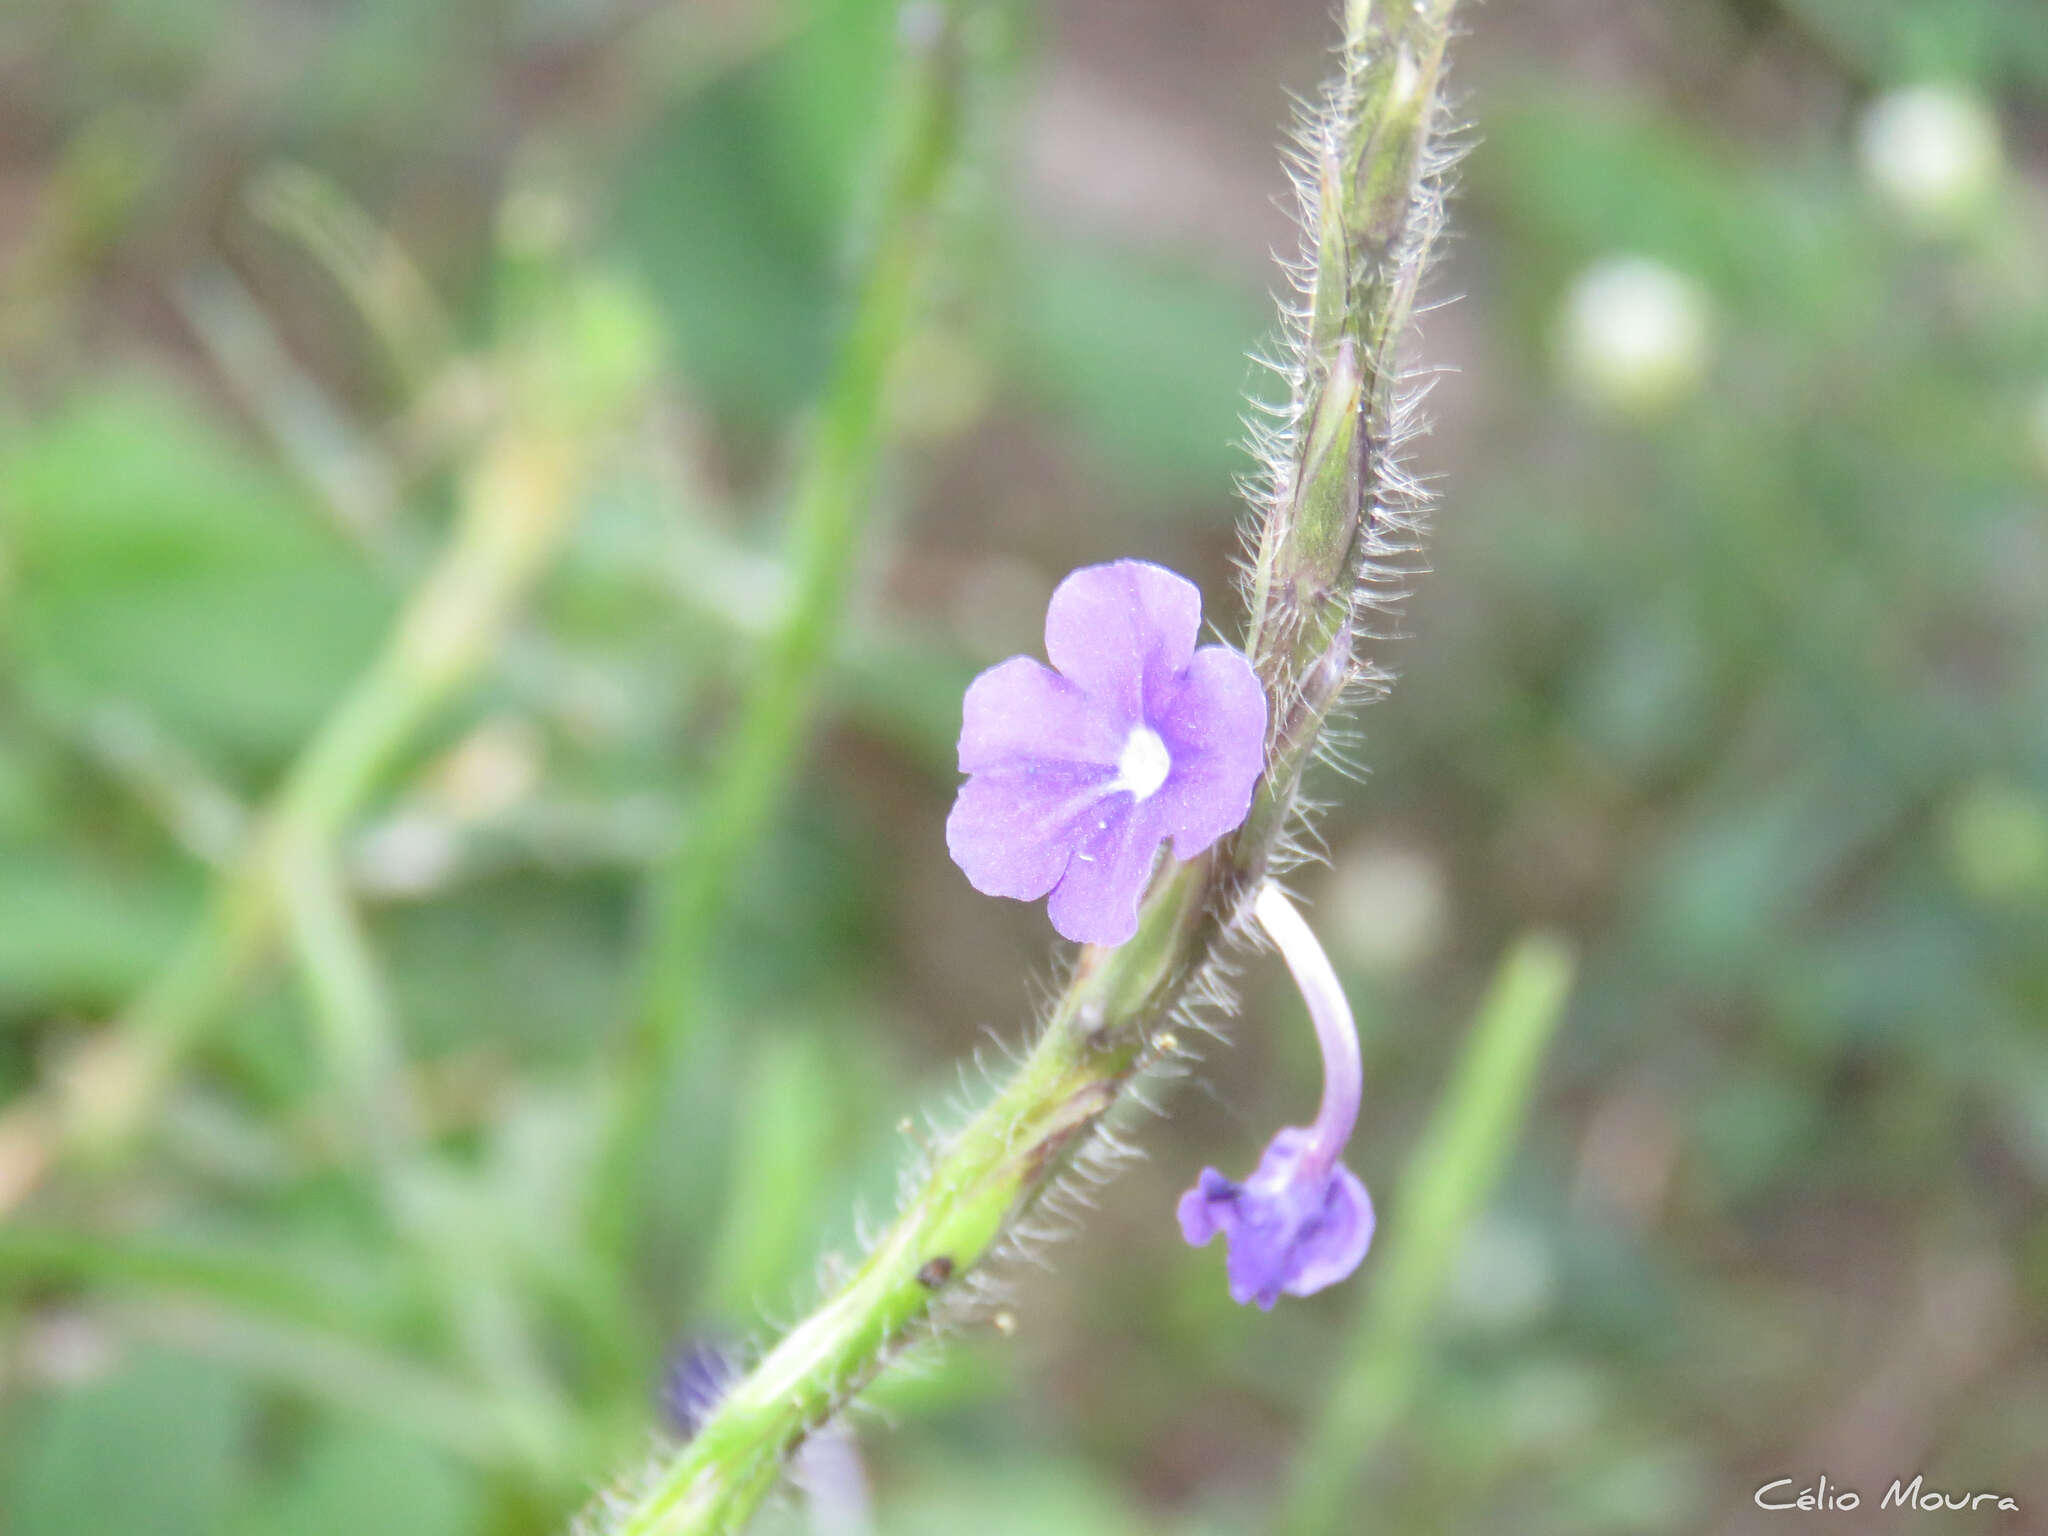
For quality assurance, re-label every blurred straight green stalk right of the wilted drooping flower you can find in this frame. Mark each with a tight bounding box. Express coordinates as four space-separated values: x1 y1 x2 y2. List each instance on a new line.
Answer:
1276 934 1575 1536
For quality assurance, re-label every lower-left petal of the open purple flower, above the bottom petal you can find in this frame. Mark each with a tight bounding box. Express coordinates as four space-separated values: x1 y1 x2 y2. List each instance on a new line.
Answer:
946 764 1114 901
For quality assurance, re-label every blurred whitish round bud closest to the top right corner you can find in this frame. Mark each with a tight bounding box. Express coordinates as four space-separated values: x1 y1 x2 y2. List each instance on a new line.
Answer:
1855 86 2001 236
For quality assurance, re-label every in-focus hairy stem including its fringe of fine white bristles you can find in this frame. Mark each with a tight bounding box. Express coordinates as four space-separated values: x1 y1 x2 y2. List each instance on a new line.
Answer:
600 0 1456 1536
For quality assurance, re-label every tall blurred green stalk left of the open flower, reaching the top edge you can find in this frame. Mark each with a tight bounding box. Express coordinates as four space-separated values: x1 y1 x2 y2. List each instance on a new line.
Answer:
598 0 991 1247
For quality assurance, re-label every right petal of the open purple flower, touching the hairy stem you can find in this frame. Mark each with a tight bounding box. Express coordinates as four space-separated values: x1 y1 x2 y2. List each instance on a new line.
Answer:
1147 645 1266 858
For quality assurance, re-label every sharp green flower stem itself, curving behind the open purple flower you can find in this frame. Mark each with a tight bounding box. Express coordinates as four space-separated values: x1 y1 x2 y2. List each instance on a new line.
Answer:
590 0 1450 1536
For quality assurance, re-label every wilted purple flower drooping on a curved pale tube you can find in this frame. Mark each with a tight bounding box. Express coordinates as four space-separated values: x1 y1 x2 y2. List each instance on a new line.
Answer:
1180 885 1372 1311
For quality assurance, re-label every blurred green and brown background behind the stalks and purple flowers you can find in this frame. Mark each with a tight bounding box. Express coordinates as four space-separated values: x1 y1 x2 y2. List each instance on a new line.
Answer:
0 0 2048 1536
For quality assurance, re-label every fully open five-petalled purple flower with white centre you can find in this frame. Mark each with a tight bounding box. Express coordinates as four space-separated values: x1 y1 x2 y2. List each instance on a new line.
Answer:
946 559 1266 944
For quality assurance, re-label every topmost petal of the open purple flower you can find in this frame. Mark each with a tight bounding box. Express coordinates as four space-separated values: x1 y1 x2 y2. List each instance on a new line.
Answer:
1044 559 1202 729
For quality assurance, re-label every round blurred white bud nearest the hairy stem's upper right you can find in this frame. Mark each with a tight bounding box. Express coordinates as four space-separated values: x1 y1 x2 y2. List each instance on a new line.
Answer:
1559 256 1712 416
